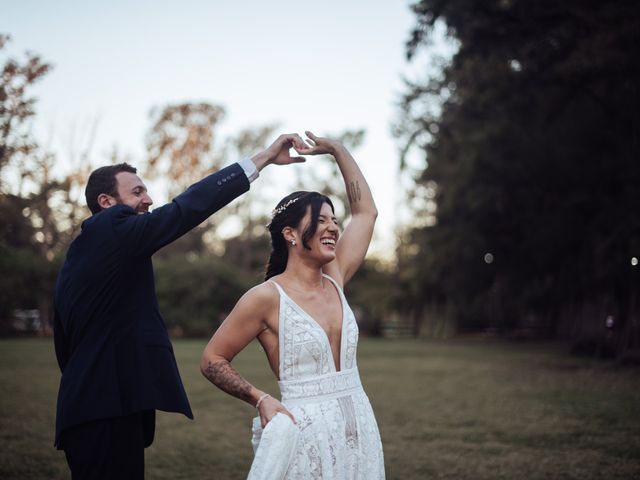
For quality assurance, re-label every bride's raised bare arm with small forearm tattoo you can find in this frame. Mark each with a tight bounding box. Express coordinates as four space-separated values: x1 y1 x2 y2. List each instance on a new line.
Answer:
299 131 378 286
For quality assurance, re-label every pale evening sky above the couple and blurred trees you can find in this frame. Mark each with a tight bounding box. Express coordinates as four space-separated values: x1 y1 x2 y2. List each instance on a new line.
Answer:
0 0 436 256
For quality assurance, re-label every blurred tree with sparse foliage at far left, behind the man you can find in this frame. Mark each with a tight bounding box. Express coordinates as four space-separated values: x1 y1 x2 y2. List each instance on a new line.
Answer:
0 35 85 332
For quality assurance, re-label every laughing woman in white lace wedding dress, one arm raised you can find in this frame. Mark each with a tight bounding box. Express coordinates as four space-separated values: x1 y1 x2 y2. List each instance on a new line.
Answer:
201 132 384 480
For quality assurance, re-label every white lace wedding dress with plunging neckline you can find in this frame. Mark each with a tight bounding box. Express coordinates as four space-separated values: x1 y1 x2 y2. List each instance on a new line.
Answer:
249 275 384 480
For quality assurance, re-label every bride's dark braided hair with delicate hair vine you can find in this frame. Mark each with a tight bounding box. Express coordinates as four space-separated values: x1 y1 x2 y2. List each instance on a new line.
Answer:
264 191 334 280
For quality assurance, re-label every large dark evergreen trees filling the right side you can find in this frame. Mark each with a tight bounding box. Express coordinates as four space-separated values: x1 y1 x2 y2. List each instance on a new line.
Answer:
398 0 640 346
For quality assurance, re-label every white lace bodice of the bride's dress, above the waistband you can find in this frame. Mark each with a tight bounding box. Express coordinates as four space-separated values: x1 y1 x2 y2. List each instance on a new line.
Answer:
272 274 358 381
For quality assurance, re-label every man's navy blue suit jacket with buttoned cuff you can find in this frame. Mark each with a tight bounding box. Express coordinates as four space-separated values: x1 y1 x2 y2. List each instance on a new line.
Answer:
54 163 249 446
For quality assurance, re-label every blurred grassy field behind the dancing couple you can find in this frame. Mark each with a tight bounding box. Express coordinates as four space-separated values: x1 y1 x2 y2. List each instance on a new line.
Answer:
0 339 640 480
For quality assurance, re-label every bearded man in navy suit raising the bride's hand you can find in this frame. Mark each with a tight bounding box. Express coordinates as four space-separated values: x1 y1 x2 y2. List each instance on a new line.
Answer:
54 134 304 480
